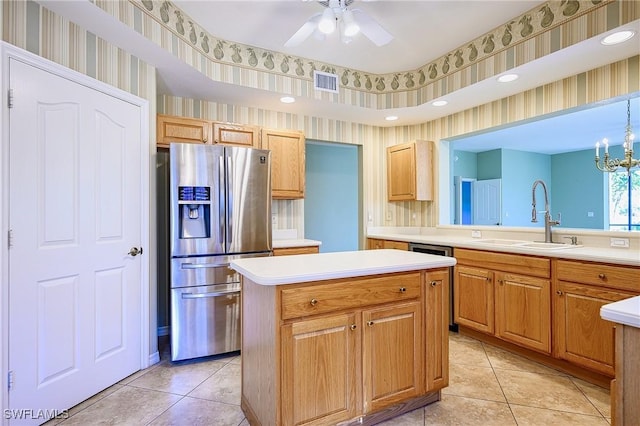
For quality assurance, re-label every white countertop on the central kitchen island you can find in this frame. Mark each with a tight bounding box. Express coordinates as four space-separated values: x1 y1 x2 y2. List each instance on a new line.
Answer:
231 250 456 285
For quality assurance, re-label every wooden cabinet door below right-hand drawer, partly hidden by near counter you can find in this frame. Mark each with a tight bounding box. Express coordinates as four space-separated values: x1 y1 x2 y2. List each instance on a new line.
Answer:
553 281 634 377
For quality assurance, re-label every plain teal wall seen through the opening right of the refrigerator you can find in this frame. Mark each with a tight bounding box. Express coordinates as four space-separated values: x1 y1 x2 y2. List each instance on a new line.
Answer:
304 140 361 253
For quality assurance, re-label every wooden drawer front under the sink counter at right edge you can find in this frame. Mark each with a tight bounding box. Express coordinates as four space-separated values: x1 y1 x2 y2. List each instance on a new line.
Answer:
556 260 640 292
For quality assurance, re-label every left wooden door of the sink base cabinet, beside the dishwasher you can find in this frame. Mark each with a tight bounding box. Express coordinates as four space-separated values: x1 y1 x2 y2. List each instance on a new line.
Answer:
453 265 494 334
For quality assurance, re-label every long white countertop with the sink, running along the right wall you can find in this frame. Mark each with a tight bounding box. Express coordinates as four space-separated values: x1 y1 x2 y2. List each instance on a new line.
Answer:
367 230 640 266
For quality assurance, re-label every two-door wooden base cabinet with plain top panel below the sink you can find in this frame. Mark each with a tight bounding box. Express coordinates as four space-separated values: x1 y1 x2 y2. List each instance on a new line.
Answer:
454 249 551 354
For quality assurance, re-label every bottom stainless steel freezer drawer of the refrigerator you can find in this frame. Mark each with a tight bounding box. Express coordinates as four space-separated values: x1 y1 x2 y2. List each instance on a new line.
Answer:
171 283 240 361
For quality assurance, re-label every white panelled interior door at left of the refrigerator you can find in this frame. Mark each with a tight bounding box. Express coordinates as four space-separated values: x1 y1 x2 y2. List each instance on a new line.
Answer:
9 59 143 423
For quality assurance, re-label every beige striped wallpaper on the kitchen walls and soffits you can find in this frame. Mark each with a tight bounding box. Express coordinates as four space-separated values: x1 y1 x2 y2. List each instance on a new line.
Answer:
2 0 640 233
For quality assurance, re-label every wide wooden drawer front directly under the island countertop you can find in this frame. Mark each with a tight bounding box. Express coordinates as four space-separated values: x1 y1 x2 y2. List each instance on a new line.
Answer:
281 272 420 319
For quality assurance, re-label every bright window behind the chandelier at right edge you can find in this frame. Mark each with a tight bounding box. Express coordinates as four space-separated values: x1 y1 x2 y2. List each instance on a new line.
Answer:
609 168 640 231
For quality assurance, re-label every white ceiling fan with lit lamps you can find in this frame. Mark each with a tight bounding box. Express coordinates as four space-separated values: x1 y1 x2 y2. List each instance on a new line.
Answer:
284 0 393 47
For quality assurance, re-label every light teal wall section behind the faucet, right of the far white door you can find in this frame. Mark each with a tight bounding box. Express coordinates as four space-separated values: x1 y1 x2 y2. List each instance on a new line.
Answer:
502 149 555 227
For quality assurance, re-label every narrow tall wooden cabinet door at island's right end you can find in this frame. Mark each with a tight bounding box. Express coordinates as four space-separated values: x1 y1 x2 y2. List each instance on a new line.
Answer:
424 269 449 392
